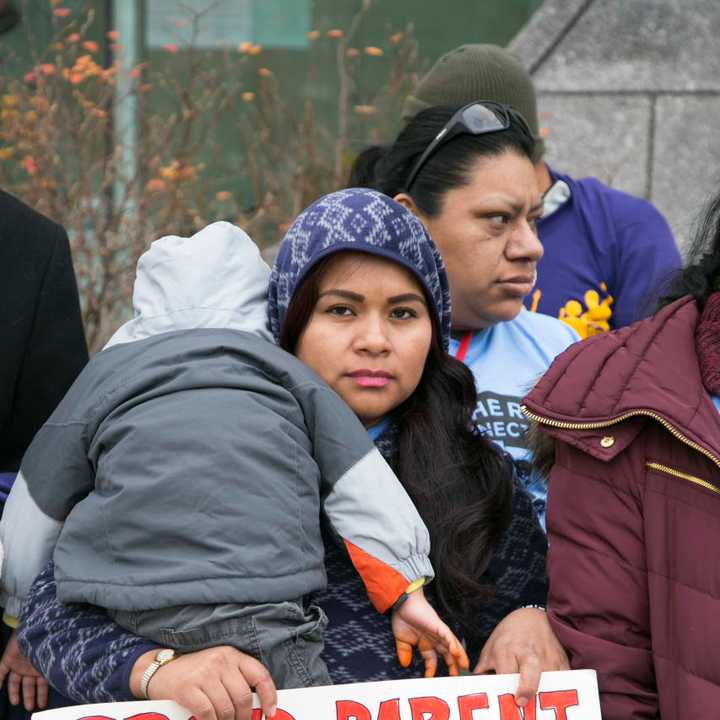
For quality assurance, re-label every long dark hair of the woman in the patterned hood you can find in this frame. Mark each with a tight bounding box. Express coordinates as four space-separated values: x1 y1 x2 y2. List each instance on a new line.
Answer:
280 256 512 634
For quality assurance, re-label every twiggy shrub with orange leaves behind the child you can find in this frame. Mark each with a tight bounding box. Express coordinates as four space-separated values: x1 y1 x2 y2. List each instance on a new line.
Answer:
0 0 417 351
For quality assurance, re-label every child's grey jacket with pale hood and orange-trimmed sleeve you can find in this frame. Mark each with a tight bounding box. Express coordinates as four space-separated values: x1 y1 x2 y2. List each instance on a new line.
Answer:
0 223 432 615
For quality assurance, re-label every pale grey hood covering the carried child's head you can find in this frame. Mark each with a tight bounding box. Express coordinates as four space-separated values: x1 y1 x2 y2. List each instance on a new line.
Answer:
104 222 272 349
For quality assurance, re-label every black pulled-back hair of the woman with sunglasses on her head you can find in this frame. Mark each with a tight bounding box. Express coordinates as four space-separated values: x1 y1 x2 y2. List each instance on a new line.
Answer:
348 105 535 217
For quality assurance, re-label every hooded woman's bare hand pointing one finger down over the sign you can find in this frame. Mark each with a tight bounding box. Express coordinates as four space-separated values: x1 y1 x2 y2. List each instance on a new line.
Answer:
474 608 570 707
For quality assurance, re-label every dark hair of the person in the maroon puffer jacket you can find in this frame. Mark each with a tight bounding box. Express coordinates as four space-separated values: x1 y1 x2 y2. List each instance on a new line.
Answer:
660 192 720 311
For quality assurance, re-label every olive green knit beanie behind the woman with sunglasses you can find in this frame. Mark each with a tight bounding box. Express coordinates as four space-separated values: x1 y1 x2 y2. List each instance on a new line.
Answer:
402 45 545 163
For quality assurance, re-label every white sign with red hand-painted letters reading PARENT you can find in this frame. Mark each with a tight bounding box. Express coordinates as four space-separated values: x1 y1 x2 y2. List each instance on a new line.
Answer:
33 670 601 720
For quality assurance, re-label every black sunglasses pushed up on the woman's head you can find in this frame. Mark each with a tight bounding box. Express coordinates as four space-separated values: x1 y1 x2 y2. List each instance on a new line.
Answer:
405 100 534 192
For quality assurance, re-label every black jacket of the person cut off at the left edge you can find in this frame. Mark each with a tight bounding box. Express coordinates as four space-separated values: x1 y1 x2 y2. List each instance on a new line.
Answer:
0 190 88 472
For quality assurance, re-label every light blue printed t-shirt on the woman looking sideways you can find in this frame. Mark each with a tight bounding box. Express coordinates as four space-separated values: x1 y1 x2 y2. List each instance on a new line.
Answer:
450 310 579 527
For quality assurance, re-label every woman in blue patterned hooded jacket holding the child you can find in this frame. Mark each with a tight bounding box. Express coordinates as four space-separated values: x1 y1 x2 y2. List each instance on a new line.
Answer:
9 190 566 718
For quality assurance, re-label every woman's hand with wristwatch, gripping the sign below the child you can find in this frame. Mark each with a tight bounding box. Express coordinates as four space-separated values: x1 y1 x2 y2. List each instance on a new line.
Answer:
130 645 277 720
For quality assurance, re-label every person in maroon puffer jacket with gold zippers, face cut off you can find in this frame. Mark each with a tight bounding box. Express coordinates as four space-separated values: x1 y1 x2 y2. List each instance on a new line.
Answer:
525 188 720 720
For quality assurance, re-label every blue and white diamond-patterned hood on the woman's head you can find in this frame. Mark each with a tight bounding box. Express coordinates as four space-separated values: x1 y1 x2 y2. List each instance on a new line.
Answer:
268 188 450 350
